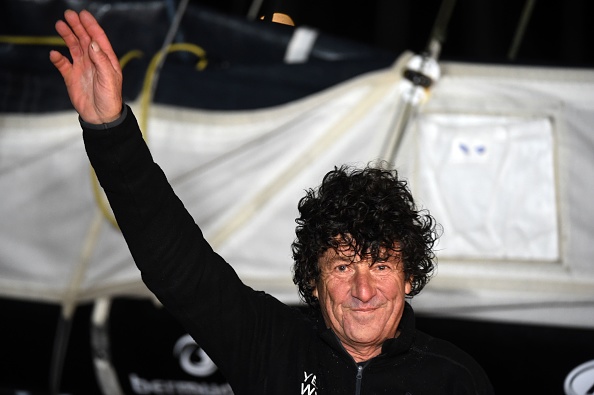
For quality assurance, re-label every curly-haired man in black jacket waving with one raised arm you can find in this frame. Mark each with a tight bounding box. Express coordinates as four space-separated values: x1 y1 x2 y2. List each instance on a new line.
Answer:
50 11 493 395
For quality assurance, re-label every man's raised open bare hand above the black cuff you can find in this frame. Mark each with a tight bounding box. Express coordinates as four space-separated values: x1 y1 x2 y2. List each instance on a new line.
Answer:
50 10 122 124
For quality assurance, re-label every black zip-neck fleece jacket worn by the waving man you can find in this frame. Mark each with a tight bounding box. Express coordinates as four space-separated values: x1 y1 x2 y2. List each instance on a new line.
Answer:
82 108 493 395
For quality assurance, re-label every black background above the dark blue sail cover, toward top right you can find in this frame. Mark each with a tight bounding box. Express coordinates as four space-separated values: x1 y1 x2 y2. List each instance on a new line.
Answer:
192 0 594 67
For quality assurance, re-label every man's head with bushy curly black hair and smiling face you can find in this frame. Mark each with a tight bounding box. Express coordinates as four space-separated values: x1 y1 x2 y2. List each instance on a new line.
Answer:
293 166 437 362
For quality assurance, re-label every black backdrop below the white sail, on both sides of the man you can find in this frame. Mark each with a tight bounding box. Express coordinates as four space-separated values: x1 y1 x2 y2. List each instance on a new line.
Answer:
0 298 594 395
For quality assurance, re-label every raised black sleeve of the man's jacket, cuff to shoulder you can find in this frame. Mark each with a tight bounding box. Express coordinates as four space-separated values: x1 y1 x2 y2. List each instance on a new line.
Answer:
82 108 294 390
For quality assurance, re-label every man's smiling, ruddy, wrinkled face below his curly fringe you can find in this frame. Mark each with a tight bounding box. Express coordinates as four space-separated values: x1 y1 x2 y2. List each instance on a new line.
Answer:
314 246 411 361
